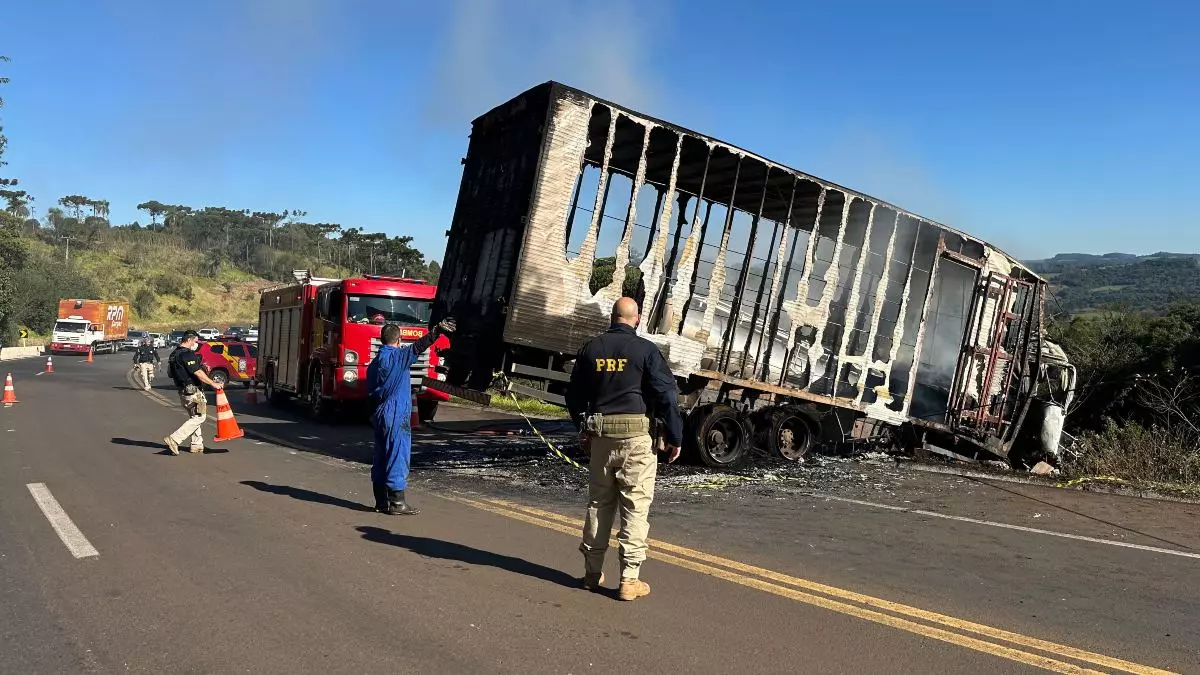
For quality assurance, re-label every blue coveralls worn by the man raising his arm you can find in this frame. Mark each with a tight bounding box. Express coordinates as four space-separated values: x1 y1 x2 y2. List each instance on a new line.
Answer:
367 340 422 490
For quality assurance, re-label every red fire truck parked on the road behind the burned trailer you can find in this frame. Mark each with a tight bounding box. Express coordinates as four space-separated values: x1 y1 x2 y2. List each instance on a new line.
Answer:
256 270 450 422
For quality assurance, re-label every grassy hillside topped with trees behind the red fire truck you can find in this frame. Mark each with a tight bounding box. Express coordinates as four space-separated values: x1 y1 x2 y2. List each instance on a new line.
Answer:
0 197 440 340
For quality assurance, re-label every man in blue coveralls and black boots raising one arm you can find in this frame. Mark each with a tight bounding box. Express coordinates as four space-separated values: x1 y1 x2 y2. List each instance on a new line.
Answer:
367 318 455 515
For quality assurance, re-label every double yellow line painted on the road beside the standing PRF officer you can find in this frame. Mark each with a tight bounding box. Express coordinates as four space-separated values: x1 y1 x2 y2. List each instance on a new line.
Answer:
439 494 1171 675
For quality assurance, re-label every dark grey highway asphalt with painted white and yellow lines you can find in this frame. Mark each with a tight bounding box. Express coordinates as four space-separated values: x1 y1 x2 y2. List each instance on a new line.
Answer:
0 354 1200 674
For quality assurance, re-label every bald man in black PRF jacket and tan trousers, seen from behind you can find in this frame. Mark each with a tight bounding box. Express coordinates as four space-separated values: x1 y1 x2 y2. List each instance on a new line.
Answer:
566 298 683 601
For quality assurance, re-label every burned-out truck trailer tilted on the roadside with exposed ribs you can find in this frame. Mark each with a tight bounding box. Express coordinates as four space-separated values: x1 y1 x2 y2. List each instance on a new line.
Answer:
432 82 1070 466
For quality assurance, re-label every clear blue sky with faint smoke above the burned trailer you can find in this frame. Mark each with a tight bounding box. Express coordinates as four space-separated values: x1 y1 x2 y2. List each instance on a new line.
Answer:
0 0 1200 258
